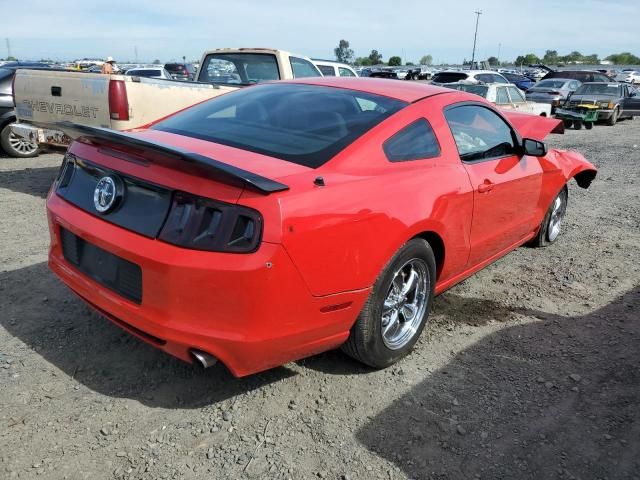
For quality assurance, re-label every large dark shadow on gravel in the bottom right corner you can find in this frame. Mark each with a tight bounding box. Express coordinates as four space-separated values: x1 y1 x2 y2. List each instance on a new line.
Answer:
357 288 640 479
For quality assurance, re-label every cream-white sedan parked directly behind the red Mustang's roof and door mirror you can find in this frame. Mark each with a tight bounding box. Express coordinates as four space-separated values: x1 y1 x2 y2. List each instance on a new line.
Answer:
443 83 551 117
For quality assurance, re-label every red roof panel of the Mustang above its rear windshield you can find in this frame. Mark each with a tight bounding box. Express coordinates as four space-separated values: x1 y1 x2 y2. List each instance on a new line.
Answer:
277 77 452 103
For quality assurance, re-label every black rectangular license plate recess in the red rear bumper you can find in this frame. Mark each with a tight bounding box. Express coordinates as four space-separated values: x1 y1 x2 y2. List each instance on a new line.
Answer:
60 227 142 304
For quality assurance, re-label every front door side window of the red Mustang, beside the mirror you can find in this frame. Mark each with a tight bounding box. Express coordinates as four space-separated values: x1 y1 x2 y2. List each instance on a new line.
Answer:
444 105 517 162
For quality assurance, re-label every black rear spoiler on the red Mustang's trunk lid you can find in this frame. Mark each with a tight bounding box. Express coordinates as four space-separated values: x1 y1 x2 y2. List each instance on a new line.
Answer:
54 122 289 195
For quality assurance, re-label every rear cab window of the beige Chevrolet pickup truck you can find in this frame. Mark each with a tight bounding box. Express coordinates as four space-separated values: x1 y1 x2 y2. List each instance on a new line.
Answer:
198 53 280 85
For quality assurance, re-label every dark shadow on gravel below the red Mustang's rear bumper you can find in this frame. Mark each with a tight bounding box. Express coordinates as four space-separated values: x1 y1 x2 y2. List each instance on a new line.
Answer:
0 262 294 408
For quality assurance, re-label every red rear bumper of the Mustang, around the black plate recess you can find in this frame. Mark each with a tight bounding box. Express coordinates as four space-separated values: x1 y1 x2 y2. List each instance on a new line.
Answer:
47 192 369 376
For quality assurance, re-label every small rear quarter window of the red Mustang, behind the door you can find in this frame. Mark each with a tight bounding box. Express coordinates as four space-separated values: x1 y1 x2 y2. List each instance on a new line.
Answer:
382 118 440 162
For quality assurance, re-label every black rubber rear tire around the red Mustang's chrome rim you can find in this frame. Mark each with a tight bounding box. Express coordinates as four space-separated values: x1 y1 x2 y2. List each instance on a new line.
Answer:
342 238 436 368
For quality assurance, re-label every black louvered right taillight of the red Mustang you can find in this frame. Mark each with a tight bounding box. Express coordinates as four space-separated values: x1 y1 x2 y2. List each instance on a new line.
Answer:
158 192 262 253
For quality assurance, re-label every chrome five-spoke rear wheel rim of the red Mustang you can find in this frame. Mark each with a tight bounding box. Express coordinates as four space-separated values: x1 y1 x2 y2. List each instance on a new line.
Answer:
381 258 430 350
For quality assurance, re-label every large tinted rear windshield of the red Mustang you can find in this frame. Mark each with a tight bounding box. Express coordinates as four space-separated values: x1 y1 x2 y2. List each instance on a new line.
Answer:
153 84 407 168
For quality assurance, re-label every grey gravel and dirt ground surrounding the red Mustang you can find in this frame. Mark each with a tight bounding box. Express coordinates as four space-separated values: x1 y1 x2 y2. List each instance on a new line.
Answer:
0 120 640 480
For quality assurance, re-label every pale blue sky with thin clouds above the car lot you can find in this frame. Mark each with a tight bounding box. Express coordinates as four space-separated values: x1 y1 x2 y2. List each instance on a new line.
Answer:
5 0 640 63
